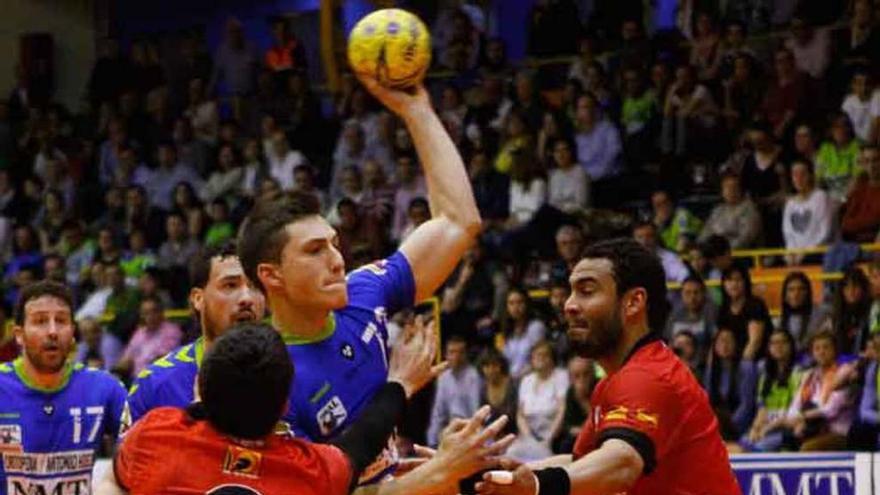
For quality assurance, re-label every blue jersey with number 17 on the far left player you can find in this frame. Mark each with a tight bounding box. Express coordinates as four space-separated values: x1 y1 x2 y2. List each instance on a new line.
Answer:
0 358 131 495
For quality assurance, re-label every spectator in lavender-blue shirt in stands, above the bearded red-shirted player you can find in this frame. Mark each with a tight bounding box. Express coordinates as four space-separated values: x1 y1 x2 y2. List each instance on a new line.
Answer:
575 93 622 207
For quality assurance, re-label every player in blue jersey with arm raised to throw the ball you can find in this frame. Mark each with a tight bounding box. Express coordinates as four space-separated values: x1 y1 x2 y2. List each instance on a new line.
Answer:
238 76 480 480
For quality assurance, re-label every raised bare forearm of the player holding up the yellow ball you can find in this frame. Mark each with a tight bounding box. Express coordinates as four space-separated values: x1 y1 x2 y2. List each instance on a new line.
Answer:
403 107 480 232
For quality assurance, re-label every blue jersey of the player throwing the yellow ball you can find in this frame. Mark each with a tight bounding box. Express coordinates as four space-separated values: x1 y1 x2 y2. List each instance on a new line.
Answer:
284 252 415 482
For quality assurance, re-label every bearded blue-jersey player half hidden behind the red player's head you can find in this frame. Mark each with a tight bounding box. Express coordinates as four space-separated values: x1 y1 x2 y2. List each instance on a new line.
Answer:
128 243 266 421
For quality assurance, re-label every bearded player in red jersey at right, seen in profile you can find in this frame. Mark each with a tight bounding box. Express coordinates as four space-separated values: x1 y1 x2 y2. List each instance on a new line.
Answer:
477 239 741 495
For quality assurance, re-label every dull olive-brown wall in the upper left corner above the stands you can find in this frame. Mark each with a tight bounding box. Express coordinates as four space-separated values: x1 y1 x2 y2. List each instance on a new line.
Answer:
0 0 95 109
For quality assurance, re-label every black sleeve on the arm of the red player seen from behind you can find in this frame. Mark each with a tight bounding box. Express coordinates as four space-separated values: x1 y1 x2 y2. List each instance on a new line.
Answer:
331 382 406 483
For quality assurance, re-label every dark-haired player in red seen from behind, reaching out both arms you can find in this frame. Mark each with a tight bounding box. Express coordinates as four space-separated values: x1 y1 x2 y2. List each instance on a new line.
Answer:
96 323 513 495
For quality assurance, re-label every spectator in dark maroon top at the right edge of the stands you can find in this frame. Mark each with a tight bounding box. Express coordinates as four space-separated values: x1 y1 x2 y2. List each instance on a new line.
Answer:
840 146 880 242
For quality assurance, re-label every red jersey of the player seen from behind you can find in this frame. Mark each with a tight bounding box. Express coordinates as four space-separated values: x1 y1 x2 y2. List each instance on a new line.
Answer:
113 407 352 495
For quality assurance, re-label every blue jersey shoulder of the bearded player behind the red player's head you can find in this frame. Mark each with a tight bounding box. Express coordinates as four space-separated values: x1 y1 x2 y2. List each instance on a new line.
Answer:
128 337 205 421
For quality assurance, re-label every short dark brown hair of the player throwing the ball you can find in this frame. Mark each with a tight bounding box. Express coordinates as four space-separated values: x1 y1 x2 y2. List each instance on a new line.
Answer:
238 191 321 290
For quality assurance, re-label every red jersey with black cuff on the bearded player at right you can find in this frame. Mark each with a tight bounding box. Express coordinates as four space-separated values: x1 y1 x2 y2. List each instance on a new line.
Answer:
574 336 741 495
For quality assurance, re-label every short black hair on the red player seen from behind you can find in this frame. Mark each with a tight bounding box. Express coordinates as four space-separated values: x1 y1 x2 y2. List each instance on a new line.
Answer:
199 323 293 440
